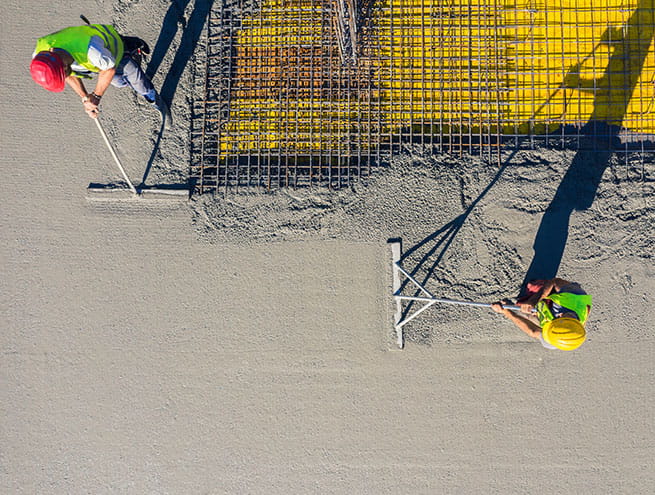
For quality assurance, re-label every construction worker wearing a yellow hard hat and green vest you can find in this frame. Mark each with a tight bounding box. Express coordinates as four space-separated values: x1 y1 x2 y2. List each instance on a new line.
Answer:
491 278 591 351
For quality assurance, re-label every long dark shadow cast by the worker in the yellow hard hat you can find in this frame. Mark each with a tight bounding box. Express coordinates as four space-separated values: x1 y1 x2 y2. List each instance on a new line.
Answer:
521 0 655 287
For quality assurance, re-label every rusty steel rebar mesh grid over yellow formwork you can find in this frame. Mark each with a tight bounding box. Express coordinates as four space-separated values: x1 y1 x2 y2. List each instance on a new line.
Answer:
191 0 655 192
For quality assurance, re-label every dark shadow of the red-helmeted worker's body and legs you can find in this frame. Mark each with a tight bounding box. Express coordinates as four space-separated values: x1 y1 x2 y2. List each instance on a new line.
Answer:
146 0 214 106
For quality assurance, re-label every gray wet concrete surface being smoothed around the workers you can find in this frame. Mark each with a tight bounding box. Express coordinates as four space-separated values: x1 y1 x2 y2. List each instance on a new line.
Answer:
0 0 655 494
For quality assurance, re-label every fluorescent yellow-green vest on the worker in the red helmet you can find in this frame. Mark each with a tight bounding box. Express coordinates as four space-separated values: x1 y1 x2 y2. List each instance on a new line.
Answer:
35 24 123 72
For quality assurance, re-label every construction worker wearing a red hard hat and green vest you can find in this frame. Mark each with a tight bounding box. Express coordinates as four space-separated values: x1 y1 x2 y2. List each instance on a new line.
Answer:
30 24 170 123
